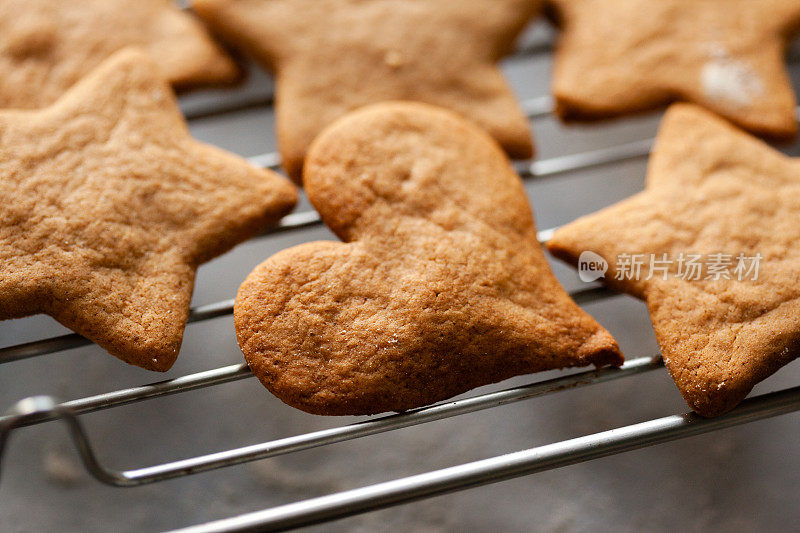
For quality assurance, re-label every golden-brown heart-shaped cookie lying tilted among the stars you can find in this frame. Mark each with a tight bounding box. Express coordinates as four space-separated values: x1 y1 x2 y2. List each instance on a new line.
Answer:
234 103 623 415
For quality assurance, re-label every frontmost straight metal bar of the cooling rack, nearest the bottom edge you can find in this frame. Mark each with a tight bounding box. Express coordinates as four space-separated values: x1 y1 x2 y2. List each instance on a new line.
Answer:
169 387 800 533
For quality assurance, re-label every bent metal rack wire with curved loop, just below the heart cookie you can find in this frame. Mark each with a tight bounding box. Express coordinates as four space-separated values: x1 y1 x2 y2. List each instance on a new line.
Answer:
0 357 662 487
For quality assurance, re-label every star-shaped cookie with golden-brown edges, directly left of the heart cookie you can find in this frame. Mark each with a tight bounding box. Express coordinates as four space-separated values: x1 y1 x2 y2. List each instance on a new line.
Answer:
0 49 296 370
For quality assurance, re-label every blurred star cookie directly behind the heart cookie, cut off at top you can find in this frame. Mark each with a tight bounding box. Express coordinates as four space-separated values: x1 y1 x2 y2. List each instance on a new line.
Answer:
192 0 541 180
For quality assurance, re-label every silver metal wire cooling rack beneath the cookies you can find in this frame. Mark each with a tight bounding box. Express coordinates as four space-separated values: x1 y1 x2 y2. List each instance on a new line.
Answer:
0 17 800 532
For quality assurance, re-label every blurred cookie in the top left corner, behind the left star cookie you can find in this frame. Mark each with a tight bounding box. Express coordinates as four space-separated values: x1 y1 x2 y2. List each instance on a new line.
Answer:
0 0 240 108
